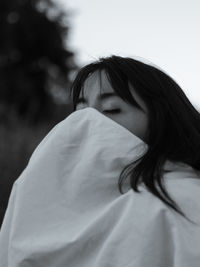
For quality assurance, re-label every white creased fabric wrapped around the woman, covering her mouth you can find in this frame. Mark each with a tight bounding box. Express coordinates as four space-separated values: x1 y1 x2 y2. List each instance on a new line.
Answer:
0 108 200 267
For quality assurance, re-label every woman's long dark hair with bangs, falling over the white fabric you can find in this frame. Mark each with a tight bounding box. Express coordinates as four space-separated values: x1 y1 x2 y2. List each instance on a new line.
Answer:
70 55 200 225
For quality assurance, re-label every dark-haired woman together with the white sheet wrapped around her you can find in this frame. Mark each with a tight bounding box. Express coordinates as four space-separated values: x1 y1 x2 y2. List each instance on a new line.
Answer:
0 56 200 267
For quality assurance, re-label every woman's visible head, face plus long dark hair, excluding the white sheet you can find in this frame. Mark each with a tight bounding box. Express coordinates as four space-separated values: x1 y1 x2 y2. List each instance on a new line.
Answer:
71 56 200 225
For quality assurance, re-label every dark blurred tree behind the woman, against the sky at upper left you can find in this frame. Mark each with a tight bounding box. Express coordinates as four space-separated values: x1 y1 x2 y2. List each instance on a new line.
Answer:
0 0 76 123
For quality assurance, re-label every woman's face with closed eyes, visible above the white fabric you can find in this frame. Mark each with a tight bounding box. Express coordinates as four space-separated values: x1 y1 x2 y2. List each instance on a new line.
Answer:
76 70 148 142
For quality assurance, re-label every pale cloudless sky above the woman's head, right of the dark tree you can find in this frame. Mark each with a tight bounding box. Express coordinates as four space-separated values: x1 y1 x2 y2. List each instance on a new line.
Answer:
54 0 200 109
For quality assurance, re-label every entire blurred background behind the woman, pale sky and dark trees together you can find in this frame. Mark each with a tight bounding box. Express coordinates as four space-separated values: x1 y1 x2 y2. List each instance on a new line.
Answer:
0 0 200 226
